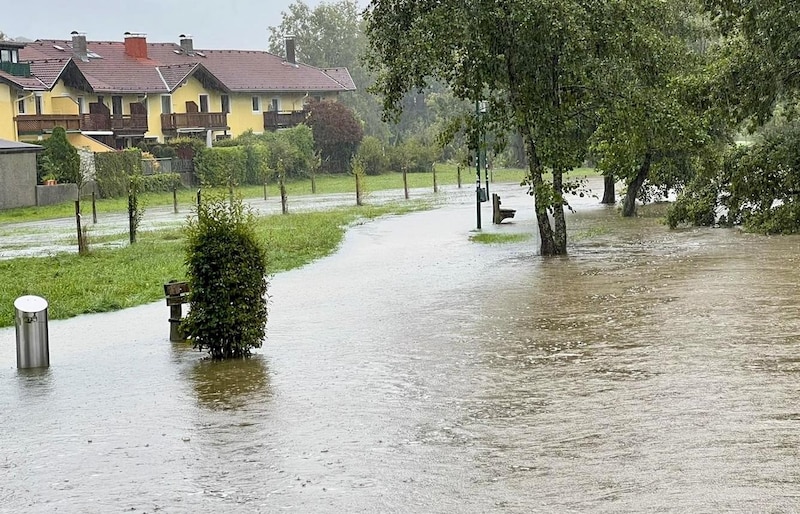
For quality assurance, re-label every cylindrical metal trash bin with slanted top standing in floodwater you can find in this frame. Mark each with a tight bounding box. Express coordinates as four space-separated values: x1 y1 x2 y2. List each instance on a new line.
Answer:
14 296 50 369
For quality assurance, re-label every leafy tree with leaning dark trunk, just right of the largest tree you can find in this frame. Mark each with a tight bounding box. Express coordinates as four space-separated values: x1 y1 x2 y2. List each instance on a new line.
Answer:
593 0 725 216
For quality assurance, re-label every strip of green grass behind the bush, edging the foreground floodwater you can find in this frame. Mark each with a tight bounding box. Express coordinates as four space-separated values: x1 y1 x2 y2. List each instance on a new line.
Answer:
0 198 429 326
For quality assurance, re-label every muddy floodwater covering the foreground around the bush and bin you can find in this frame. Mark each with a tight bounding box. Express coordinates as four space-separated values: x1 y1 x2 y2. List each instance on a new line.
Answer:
0 184 800 513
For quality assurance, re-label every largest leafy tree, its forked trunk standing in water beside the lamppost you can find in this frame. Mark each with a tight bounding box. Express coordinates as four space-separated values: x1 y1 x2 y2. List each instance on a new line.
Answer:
365 0 661 255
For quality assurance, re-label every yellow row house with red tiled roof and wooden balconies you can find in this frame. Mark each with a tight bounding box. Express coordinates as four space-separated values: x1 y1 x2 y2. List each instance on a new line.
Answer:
0 32 355 151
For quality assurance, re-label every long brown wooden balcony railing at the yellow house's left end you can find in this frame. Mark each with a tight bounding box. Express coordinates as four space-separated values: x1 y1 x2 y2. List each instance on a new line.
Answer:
14 113 148 135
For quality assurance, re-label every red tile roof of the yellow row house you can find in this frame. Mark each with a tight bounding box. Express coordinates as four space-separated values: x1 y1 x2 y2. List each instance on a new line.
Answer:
14 40 355 93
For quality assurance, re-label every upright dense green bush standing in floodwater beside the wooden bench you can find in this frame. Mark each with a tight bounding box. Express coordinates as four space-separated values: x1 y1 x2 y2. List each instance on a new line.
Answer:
184 190 267 359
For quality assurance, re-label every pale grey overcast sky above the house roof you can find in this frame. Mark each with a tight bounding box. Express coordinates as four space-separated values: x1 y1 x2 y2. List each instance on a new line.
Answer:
5 0 368 50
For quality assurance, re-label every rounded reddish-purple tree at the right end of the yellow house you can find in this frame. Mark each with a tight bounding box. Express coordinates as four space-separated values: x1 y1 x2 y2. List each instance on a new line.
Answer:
306 101 364 173
